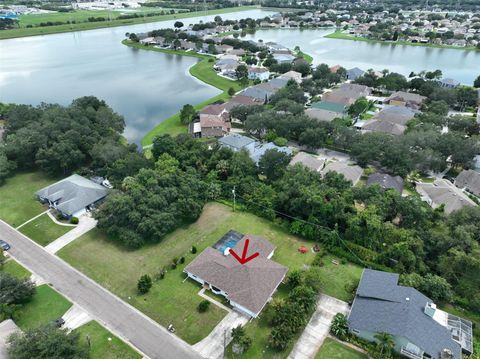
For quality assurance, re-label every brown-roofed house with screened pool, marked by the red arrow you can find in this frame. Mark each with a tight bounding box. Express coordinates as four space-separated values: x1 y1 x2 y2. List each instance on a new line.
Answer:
184 232 288 318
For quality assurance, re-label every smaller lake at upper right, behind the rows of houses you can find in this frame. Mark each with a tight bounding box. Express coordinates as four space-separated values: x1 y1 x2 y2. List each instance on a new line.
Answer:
247 29 480 85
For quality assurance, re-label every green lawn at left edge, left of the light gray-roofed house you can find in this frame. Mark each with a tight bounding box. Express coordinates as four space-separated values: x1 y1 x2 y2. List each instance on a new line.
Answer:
0 172 55 227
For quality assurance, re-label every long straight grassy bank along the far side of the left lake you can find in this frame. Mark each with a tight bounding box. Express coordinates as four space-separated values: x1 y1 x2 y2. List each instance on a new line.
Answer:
0 6 258 40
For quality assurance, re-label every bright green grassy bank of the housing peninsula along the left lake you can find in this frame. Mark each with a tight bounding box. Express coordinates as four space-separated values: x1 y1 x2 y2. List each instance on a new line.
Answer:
122 40 248 146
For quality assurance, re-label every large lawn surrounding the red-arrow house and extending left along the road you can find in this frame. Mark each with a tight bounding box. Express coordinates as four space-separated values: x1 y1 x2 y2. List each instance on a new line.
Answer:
59 203 313 343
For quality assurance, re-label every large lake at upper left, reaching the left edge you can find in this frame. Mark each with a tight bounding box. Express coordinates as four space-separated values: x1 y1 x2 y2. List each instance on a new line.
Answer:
0 10 272 143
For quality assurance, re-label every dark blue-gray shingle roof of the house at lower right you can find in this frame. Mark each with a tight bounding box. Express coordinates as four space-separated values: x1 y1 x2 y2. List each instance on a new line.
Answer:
348 269 461 359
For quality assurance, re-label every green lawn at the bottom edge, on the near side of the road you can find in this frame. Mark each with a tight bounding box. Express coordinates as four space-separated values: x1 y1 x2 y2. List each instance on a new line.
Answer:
74 320 142 359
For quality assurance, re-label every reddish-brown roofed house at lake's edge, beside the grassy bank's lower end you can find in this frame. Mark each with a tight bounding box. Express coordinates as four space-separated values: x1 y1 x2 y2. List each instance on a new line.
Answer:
200 104 232 137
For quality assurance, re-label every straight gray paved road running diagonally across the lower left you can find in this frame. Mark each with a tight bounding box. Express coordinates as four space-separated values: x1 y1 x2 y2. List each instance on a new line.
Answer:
0 221 200 359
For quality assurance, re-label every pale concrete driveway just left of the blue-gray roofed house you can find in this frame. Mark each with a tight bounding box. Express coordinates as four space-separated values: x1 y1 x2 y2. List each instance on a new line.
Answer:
288 294 349 359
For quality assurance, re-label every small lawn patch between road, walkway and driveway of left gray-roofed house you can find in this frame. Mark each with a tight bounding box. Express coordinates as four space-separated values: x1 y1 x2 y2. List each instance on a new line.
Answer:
20 214 74 246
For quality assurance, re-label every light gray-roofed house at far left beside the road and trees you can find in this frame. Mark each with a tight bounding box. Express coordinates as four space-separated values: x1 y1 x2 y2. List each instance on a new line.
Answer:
36 174 108 218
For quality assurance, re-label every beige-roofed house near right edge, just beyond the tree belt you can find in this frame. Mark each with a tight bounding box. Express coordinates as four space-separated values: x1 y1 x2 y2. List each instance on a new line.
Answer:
415 179 476 213
